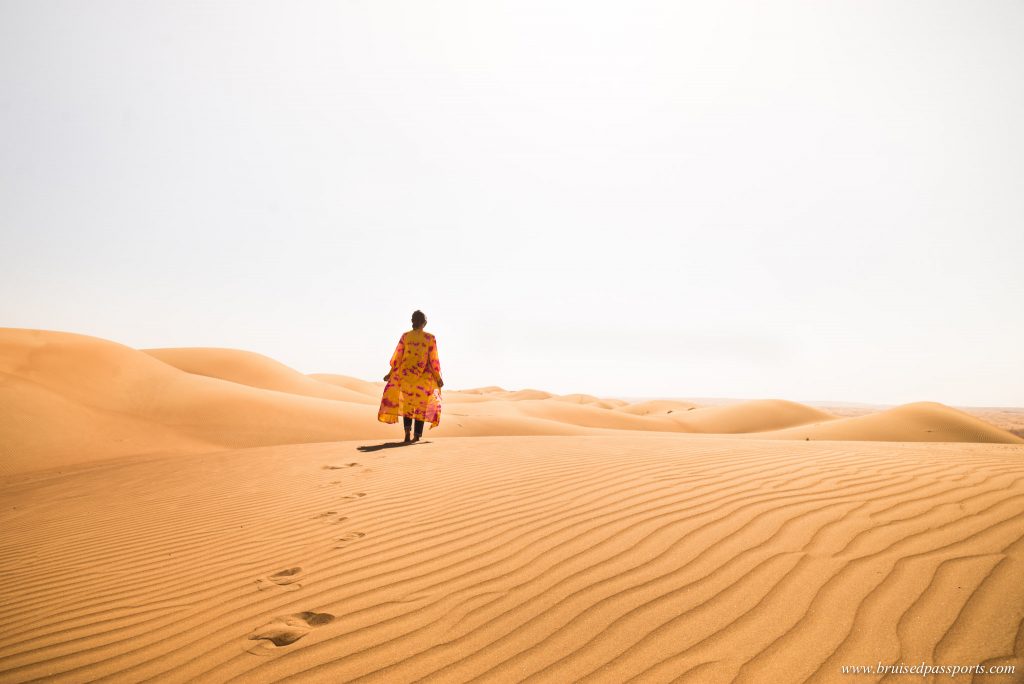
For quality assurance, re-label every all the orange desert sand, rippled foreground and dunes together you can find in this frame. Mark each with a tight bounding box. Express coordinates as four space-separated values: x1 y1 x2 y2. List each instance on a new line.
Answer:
0 329 1024 683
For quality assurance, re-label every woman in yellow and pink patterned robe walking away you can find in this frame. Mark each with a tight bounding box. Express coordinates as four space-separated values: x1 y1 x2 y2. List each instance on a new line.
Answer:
377 310 444 442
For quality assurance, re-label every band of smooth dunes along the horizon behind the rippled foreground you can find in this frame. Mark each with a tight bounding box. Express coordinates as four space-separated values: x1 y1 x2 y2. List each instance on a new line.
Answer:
0 329 1024 472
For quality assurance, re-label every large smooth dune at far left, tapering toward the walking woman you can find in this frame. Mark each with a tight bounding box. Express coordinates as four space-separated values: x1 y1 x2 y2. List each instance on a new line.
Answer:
0 329 393 472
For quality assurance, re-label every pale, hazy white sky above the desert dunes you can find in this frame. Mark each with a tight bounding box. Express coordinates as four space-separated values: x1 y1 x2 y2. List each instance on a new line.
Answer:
0 0 1024 405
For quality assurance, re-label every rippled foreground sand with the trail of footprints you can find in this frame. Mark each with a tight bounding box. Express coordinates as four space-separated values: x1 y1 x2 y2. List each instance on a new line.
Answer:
0 432 1024 684
